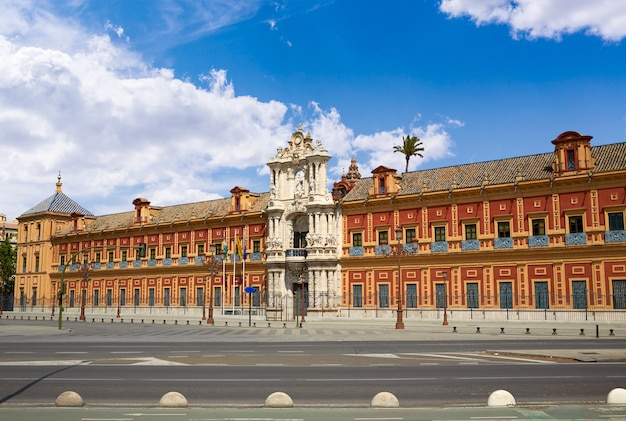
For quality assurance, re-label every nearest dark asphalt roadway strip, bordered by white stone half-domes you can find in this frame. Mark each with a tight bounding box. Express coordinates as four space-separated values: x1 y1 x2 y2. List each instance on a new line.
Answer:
0 361 626 406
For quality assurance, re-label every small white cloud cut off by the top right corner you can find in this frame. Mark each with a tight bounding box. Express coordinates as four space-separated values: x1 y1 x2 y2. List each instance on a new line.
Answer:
440 0 626 41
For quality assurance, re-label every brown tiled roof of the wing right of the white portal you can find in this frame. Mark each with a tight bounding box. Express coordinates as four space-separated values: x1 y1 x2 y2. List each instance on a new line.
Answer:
343 143 626 202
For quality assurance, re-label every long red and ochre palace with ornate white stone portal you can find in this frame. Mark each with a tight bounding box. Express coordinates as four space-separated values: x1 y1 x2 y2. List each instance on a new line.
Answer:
14 128 626 320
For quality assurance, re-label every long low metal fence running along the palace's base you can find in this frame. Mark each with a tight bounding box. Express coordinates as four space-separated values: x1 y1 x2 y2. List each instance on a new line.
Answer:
8 289 626 320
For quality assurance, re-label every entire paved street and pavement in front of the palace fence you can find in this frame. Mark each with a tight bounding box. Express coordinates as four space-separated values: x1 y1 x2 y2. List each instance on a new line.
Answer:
0 316 626 421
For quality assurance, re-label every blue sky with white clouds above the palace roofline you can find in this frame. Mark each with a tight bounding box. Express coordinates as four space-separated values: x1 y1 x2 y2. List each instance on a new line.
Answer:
0 0 626 219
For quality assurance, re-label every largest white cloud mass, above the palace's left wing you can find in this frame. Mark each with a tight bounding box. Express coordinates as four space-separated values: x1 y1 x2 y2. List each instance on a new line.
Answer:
0 6 291 217
